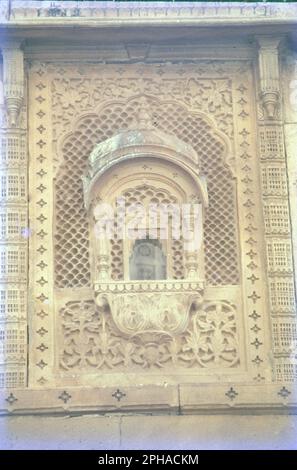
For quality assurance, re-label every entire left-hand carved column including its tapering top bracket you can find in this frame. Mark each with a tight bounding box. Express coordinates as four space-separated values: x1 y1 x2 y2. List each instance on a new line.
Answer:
0 41 29 389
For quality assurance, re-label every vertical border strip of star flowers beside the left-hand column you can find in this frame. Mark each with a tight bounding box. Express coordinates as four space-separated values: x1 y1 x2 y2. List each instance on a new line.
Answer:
29 62 55 387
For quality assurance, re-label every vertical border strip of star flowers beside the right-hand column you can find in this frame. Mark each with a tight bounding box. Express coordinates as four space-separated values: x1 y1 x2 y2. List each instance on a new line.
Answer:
233 72 271 382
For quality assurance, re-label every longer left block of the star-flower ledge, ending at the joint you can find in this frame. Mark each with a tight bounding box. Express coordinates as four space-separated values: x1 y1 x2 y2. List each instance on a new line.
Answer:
0 385 178 414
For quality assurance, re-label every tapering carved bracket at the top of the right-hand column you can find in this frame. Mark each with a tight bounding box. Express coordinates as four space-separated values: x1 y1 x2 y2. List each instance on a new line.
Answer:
257 36 280 119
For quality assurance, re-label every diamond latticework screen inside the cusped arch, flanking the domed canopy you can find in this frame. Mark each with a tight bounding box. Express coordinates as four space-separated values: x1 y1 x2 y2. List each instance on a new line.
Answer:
55 99 239 287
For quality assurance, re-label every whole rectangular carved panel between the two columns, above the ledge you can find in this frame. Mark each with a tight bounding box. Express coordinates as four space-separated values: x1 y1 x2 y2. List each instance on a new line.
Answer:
29 57 268 388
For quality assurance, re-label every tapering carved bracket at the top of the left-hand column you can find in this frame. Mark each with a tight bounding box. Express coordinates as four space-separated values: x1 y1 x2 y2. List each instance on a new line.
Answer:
1 42 24 127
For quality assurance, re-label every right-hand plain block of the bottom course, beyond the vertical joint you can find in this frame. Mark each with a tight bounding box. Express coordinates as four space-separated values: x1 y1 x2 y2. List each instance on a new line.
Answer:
122 415 297 449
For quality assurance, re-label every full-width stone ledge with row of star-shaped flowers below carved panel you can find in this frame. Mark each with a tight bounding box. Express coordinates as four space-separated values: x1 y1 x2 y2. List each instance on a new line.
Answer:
0 383 297 415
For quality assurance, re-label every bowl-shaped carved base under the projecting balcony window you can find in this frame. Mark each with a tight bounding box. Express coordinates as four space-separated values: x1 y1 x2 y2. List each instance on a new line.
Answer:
95 281 203 343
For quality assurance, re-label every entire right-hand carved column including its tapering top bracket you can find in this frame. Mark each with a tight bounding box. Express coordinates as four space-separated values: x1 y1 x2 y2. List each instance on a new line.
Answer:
257 36 296 382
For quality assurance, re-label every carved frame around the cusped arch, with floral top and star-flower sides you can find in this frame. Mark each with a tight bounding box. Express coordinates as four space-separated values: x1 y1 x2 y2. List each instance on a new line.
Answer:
29 61 272 387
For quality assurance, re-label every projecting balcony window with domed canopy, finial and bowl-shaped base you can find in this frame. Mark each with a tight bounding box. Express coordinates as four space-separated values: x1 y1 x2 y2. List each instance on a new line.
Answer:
84 101 207 342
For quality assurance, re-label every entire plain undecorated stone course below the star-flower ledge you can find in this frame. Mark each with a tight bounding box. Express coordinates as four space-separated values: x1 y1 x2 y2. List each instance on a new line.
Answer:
0 415 297 450
